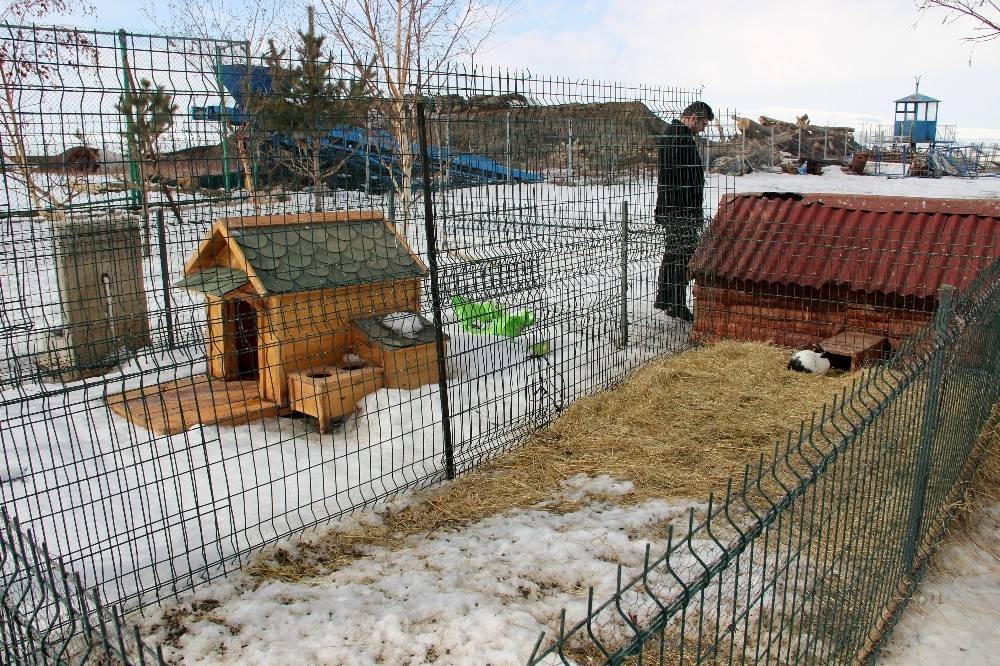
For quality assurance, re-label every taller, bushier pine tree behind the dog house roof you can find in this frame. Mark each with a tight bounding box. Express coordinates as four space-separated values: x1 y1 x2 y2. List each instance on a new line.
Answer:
254 7 369 211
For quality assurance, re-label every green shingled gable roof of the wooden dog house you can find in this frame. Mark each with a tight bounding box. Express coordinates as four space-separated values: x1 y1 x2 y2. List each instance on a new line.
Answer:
177 214 425 296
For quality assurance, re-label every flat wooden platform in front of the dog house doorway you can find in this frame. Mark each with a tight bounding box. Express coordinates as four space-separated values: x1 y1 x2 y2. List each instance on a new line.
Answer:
107 375 279 435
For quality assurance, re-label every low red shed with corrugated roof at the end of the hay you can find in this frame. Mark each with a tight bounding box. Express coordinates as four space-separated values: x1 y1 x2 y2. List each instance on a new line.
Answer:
690 192 1000 348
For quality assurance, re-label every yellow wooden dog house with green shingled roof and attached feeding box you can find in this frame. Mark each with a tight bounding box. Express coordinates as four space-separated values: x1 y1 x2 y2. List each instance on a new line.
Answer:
108 211 446 429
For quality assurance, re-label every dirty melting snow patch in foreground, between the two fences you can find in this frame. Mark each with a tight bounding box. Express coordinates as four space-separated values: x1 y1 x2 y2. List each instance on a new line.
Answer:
143 477 708 665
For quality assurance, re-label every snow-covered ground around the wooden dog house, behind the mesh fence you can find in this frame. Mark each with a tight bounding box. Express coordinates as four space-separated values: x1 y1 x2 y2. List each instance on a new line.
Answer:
0 176 683 605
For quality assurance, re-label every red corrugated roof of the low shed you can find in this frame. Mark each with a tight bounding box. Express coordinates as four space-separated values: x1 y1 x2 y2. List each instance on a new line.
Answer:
691 192 1000 298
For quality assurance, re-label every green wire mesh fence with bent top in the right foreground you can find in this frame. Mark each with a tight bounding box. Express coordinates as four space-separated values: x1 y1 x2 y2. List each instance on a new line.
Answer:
530 264 1000 664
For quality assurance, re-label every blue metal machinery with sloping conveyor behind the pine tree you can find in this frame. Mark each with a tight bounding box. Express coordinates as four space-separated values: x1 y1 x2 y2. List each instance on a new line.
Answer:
191 65 544 191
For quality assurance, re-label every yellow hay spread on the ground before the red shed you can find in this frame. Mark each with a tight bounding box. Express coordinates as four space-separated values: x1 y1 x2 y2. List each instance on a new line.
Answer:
250 342 855 580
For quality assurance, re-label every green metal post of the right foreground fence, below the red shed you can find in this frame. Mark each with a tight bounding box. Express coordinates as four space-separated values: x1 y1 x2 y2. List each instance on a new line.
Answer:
903 285 954 571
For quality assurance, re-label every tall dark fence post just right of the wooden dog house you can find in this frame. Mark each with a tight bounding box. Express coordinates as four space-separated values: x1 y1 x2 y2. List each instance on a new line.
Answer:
416 100 455 479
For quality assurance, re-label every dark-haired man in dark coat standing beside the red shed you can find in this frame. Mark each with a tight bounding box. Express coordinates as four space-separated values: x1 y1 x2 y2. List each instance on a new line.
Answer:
653 102 715 321
